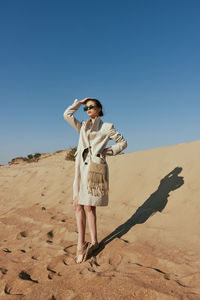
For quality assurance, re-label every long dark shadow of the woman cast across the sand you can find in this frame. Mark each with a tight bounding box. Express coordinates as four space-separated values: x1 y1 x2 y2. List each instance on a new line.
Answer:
90 167 184 256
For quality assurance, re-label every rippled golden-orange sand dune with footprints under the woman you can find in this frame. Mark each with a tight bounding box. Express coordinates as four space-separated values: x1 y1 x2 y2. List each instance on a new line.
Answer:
0 141 200 300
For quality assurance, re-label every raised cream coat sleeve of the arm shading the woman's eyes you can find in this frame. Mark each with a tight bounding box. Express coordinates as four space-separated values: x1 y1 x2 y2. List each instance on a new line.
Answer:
63 99 82 132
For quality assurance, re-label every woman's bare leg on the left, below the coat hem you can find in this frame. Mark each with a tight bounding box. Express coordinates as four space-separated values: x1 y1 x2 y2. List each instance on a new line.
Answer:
73 197 86 263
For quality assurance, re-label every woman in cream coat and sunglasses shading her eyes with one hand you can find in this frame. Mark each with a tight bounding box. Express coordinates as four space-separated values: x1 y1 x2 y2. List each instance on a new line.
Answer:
64 98 127 263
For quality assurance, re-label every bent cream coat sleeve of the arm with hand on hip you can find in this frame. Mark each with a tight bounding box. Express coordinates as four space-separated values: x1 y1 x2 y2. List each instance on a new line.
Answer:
109 124 127 155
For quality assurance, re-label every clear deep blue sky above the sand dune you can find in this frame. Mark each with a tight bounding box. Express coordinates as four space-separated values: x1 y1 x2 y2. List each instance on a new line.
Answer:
0 0 200 164
